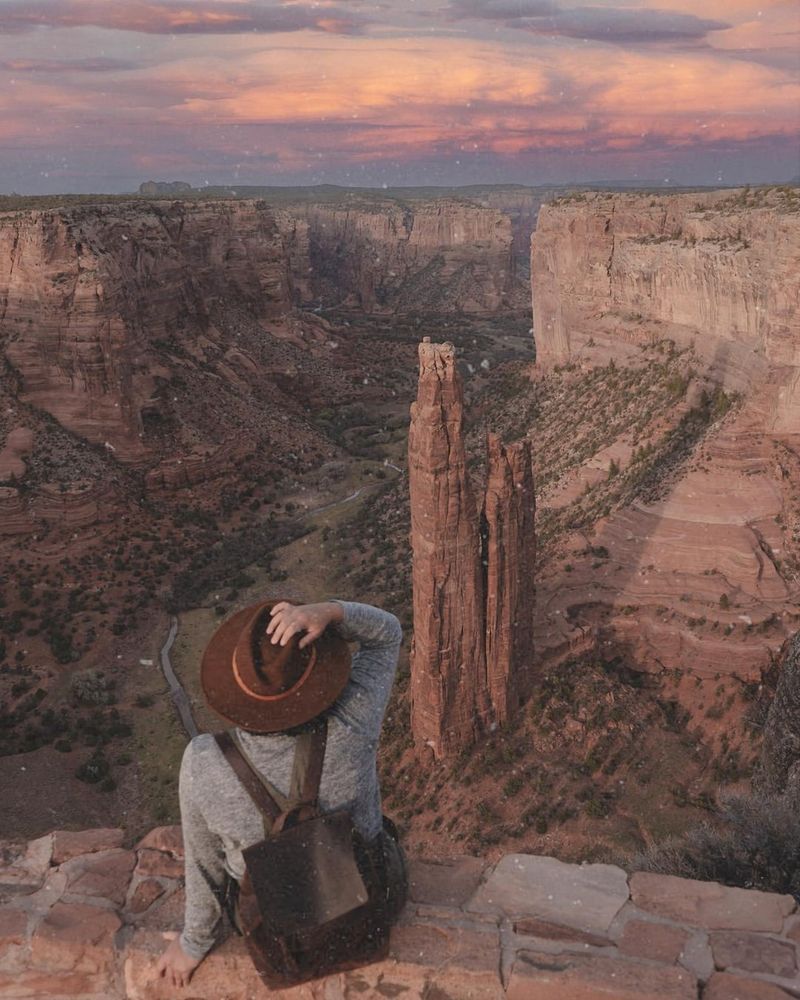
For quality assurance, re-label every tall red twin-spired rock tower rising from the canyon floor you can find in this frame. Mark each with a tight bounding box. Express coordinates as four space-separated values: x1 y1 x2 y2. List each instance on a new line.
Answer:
408 338 535 757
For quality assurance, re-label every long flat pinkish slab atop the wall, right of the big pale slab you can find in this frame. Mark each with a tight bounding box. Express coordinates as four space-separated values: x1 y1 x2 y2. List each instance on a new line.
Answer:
631 872 796 932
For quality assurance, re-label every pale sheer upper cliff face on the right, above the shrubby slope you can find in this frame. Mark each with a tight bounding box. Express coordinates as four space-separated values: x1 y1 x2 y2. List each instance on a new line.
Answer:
531 190 800 388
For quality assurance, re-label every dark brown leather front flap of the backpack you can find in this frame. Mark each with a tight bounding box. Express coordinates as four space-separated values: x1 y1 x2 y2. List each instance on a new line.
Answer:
242 810 369 936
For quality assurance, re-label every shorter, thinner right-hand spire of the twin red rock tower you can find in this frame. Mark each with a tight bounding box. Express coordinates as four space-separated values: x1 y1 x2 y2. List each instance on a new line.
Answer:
484 434 536 723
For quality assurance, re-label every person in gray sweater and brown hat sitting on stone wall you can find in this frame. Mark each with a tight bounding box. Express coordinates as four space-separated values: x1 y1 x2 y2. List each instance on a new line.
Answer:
157 600 403 987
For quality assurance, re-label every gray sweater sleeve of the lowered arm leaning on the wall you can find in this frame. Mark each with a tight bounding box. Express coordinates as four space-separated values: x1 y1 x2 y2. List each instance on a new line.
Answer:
179 743 226 958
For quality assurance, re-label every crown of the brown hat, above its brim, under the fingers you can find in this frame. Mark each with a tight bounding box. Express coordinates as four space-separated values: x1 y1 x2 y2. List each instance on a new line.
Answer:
233 607 315 698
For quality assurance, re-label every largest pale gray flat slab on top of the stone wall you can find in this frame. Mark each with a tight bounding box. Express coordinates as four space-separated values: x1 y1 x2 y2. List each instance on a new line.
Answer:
466 854 628 934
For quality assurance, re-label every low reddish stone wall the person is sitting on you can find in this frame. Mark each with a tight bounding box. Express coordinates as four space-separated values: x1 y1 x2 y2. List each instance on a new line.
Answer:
0 827 800 1000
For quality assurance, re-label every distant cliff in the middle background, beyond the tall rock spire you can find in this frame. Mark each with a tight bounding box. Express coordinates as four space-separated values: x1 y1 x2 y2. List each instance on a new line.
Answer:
287 197 521 314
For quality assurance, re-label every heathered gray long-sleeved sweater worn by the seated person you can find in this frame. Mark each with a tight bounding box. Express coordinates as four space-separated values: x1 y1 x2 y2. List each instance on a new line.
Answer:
179 601 403 958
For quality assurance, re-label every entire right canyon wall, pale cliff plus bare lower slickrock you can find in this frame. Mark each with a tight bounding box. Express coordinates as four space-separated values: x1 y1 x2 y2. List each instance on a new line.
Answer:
531 189 800 683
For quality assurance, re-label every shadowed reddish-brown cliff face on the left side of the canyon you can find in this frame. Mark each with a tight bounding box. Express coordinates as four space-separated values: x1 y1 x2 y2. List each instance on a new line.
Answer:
0 201 295 463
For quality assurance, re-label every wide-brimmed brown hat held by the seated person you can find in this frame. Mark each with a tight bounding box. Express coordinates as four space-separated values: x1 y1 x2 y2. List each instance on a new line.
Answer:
200 598 350 733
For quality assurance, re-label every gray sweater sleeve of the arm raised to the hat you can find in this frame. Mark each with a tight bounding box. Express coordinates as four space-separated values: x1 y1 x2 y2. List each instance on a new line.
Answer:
324 600 403 745
